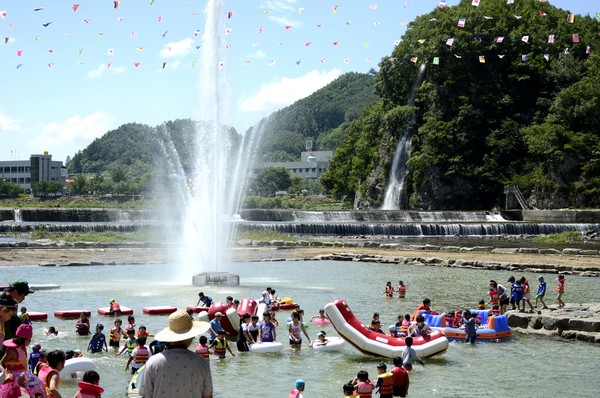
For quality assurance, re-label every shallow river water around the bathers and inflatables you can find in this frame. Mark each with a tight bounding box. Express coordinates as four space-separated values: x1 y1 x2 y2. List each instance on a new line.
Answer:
0 261 600 398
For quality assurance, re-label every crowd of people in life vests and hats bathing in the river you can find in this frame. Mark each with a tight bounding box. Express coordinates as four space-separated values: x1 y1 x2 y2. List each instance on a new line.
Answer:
0 275 565 398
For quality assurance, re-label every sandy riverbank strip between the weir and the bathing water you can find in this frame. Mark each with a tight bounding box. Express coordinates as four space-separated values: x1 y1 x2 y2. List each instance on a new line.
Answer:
0 245 600 268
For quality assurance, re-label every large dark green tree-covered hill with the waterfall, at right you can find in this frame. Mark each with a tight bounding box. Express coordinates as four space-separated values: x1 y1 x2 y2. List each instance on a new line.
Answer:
322 0 600 209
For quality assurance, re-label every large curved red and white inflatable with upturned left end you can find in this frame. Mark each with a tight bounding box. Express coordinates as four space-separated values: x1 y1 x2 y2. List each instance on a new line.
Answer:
325 300 449 358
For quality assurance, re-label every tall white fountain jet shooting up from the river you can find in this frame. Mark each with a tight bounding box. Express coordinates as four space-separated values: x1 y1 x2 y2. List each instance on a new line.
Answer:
167 0 244 280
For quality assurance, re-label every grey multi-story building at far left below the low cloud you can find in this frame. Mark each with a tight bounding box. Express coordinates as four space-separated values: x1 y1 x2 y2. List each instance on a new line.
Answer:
0 151 67 190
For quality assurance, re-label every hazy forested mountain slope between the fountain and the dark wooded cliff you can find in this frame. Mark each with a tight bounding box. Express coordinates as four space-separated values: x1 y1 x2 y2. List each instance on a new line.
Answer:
258 71 377 161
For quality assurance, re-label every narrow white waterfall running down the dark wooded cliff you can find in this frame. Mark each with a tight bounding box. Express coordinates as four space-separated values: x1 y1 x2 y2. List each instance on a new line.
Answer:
381 64 425 210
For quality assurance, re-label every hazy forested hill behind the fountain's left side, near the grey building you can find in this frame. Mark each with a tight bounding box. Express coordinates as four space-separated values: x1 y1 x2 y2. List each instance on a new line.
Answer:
67 119 241 193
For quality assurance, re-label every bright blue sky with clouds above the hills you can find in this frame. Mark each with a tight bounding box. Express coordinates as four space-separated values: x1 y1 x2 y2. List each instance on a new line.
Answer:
0 0 600 160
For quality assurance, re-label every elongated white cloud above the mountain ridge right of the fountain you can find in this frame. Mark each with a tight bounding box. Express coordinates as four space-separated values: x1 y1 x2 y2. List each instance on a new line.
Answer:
240 69 340 114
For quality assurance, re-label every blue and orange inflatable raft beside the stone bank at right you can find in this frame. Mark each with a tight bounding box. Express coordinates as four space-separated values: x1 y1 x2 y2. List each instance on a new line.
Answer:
425 310 512 341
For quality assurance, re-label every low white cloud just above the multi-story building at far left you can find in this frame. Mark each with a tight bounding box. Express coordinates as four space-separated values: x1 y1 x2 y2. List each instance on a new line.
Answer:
27 112 113 154
